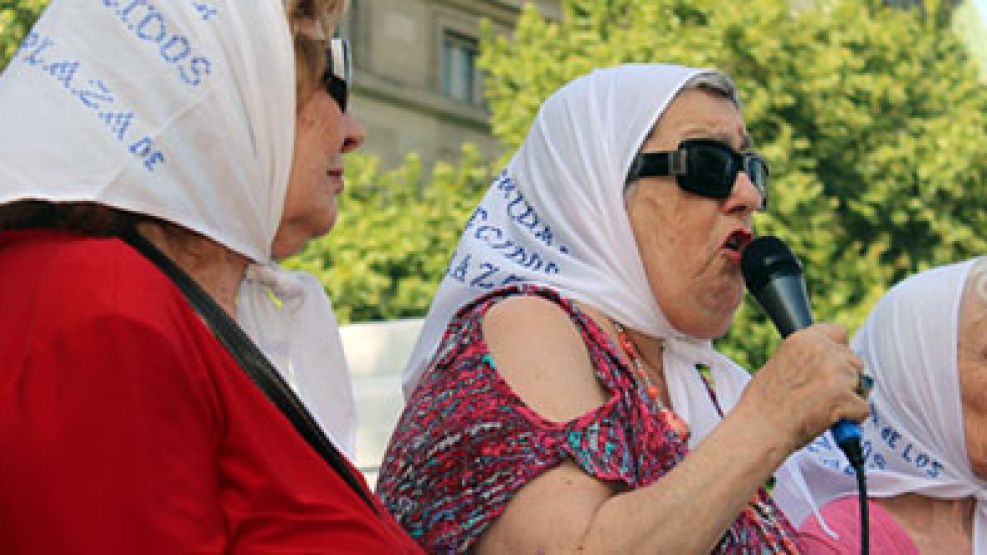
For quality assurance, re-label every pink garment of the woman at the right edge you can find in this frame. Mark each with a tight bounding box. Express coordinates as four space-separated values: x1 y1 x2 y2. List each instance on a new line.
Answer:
799 495 919 555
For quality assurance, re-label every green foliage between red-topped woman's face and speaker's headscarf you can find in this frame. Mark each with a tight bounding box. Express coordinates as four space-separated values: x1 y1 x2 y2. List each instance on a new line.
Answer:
284 145 492 323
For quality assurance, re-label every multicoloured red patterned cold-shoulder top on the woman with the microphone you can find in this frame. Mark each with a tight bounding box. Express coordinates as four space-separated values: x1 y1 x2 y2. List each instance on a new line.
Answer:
377 284 798 554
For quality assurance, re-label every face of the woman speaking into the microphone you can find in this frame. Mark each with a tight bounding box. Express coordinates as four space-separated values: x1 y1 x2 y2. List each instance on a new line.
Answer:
627 89 761 338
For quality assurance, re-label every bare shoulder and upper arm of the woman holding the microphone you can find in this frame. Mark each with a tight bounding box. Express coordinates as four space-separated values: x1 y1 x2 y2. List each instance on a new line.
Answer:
475 296 616 553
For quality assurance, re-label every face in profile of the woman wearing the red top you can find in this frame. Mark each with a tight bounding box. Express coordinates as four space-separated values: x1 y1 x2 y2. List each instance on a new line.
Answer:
271 2 364 258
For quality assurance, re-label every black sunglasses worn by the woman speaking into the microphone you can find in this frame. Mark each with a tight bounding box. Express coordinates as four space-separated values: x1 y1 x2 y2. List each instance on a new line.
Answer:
627 139 768 210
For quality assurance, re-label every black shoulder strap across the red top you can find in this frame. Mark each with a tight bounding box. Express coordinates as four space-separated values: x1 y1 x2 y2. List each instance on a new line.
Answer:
123 231 377 513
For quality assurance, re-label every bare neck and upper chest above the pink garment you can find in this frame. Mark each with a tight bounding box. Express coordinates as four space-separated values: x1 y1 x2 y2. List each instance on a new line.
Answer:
878 493 976 553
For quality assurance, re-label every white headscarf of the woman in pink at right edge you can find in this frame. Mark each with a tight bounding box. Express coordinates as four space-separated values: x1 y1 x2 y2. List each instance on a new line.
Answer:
776 260 987 555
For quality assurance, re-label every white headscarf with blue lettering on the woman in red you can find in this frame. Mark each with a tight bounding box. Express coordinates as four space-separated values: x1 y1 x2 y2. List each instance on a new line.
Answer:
0 0 354 451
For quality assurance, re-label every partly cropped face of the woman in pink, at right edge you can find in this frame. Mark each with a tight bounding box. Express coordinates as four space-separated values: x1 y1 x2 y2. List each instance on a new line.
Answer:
958 268 987 479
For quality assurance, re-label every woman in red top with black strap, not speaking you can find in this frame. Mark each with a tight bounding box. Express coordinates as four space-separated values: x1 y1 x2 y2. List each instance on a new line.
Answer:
0 0 418 554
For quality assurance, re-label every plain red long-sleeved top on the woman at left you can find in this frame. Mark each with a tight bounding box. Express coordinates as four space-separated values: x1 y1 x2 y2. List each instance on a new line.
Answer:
0 231 418 554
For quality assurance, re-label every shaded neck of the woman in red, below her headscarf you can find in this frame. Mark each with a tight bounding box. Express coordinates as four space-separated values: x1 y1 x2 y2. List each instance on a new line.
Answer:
137 221 249 318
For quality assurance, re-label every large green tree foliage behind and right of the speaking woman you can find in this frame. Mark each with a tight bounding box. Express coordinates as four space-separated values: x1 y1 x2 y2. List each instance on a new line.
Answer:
480 0 987 368
